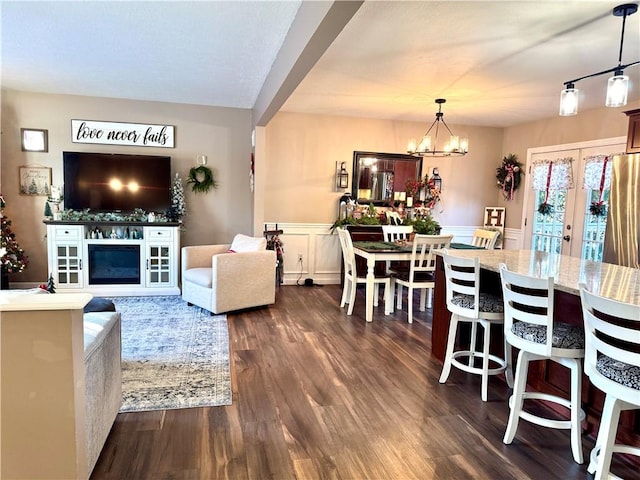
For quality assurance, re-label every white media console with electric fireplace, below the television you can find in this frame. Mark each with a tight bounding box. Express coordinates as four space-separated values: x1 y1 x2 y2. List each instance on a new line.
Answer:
45 221 180 296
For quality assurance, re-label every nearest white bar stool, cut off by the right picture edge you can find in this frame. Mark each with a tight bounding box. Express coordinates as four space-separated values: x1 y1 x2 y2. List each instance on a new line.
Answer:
580 283 640 480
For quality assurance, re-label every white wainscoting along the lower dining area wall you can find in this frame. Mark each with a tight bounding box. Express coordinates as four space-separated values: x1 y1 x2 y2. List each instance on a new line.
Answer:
271 222 521 285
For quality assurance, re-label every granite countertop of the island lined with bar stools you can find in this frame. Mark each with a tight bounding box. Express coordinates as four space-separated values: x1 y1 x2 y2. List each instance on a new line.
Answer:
440 250 640 305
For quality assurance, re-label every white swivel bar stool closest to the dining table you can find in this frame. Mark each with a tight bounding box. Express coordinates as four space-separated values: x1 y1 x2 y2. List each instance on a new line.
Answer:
439 249 513 402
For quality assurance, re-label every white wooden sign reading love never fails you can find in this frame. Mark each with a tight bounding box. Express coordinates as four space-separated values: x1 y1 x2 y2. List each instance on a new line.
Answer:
71 120 175 148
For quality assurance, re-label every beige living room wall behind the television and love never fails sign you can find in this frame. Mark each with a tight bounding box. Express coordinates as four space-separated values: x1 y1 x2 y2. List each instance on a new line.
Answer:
0 90 253 282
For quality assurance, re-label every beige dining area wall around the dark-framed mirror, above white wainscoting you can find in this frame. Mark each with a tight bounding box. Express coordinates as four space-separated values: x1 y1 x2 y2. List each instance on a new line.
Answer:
265 112 502 226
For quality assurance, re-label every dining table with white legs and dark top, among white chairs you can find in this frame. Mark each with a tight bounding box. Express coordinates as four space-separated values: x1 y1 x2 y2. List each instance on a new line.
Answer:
353 241 481 322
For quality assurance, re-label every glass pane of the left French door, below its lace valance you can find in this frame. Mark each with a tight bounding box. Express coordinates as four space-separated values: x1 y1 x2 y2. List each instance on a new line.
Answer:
531 190 567 253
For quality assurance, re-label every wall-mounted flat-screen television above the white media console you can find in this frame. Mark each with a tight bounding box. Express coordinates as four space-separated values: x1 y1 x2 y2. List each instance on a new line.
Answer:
62 152 171 212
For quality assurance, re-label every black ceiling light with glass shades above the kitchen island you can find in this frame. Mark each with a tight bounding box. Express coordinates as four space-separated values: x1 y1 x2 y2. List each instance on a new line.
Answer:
560 3 640 117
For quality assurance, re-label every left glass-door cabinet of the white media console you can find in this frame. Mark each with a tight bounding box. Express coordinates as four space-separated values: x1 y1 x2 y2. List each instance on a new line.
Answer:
47 225 84 289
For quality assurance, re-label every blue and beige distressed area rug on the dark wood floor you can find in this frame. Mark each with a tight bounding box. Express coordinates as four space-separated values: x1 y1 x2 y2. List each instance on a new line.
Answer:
110 295 231 412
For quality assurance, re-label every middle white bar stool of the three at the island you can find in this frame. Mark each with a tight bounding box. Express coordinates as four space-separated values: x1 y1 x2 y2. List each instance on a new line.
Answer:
500 263 585 463
